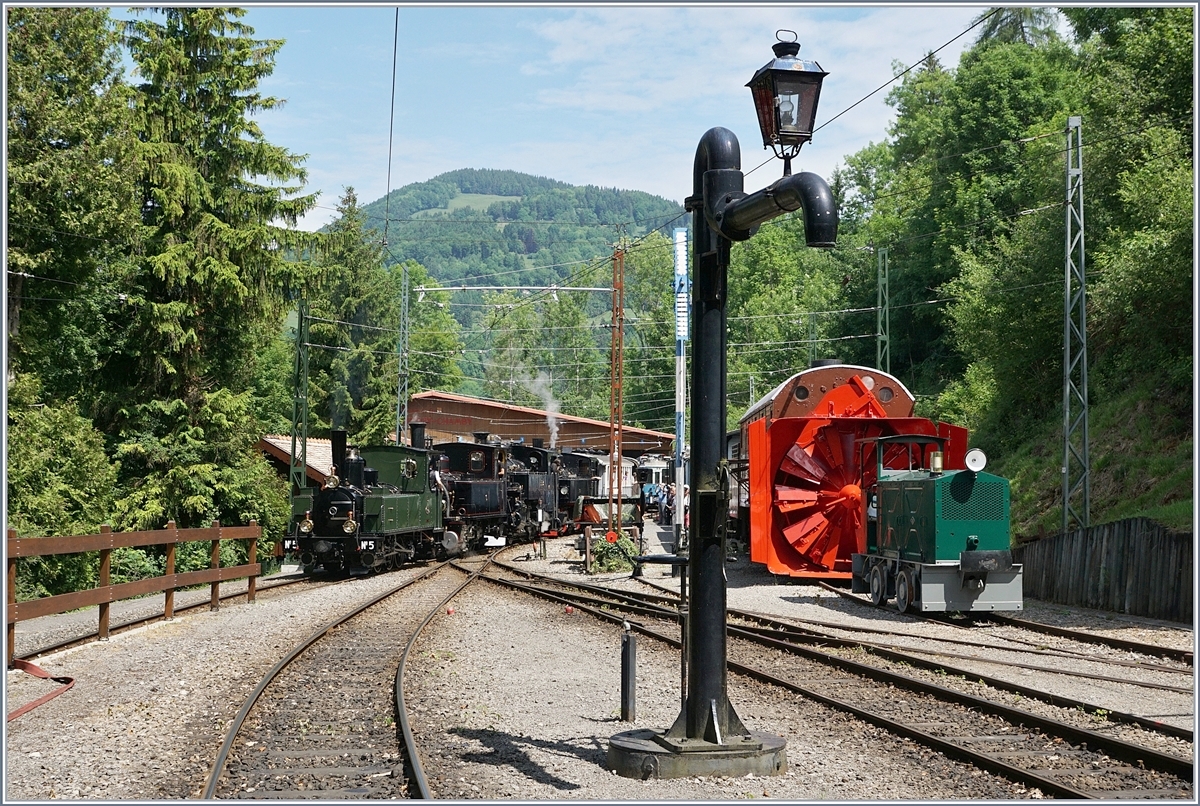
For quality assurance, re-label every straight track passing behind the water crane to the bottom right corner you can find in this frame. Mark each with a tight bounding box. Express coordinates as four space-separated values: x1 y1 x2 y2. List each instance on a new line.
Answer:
486 566 1193 799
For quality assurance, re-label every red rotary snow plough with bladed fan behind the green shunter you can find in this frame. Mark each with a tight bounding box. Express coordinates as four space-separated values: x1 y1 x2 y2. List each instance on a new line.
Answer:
739 365 967 579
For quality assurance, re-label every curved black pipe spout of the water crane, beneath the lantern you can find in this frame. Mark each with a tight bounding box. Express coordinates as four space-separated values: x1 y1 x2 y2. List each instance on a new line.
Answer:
713 173 838 248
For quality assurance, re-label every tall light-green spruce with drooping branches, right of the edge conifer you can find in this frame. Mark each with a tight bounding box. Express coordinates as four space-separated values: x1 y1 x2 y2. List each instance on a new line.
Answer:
118 8 316 409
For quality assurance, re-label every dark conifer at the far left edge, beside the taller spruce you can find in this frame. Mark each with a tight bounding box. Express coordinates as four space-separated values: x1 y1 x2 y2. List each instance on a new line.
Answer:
6 7 138 409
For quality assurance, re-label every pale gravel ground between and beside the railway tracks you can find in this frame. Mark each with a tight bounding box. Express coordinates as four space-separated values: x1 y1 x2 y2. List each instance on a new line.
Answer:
5 527 1194 801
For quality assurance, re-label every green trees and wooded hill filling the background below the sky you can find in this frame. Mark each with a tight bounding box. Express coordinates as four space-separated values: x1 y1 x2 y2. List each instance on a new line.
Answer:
6 7 1194 596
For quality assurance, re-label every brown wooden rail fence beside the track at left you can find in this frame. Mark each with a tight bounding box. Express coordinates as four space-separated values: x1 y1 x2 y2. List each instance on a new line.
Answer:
5 521 262 667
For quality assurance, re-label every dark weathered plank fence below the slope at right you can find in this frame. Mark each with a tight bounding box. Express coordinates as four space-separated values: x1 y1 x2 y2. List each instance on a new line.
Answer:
1013 518 1195 624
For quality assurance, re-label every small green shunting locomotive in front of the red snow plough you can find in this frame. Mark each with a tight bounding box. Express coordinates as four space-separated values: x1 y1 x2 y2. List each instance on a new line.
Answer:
851 434 1022 613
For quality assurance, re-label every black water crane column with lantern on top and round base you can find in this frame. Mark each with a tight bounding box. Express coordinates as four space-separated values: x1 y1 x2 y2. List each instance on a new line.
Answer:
608 32 838 778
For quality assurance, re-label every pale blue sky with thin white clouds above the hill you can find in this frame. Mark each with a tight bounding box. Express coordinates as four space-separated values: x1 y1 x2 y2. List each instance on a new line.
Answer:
140 4 1008 229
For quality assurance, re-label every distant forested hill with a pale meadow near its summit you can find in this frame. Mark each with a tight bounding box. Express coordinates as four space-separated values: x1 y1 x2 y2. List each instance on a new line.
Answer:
364 168 683 296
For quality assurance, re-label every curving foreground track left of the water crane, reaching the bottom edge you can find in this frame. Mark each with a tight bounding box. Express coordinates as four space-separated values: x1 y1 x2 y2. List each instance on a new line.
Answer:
203 558 491 800
